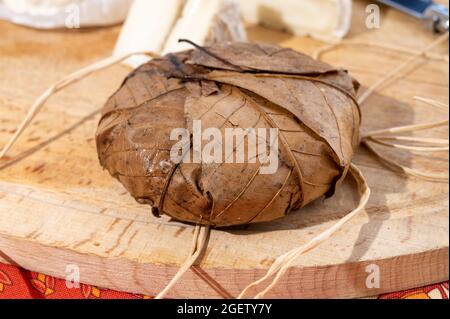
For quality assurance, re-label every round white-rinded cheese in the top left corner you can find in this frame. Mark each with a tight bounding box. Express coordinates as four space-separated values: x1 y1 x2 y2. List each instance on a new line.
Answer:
0 0 133 29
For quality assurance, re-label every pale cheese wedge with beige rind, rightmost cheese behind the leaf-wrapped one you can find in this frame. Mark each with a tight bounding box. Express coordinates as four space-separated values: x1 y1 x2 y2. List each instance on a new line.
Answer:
240 0 352 42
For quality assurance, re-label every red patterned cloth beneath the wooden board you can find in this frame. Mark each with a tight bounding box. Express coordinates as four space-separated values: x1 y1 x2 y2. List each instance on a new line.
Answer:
0 264 449 299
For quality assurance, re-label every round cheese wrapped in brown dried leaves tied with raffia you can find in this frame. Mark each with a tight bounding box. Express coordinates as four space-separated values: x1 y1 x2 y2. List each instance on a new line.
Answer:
96 43 361 227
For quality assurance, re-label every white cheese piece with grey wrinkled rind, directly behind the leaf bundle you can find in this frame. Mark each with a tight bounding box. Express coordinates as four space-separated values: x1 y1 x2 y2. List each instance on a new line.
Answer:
163 0 247 54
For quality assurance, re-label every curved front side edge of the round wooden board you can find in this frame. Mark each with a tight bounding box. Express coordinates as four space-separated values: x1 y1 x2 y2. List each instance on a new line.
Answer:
0 234 449 298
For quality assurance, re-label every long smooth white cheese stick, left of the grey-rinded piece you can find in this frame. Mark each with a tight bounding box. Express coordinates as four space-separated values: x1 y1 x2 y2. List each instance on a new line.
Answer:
113 0 184 68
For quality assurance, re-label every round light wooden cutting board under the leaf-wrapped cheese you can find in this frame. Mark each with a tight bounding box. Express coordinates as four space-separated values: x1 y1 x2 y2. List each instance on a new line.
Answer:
0 1 449 298
